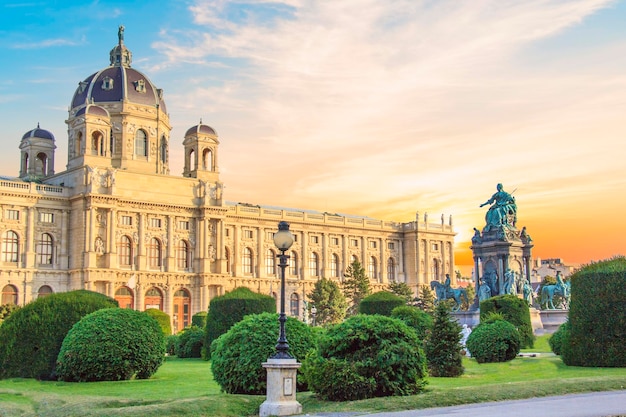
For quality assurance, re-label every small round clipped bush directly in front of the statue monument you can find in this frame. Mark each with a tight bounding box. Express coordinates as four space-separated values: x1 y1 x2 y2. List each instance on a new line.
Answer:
466 320 521 363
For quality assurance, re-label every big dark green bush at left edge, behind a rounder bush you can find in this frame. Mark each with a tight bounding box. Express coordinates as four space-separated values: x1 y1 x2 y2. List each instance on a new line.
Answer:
0 290 118 379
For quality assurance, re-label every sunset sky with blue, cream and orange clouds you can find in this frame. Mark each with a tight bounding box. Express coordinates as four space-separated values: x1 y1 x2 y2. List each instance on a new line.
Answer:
0 0 626 272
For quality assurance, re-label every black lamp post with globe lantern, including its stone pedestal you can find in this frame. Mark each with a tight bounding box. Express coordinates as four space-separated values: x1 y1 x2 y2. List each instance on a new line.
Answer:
259 222 302 417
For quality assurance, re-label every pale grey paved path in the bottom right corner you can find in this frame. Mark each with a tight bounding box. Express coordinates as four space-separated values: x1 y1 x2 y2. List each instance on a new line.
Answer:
300 390 626 417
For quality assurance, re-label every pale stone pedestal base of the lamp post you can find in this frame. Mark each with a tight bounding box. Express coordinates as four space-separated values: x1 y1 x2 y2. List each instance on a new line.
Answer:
259 358 302 417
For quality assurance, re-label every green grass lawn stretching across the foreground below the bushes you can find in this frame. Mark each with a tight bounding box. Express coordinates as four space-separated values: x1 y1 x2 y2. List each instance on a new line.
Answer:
0 336 626 417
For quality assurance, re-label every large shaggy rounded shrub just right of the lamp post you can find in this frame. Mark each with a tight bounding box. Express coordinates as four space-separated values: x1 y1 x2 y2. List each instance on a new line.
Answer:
302 314 427 401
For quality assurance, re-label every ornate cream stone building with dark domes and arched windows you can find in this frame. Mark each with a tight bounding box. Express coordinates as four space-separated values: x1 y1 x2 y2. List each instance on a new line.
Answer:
0 31 455 329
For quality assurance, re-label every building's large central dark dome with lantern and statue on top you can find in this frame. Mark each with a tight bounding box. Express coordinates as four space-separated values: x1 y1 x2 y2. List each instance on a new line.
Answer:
71 27 167 113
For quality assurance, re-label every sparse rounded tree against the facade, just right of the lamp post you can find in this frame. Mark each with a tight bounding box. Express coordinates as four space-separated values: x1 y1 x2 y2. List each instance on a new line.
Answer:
308 278 348 325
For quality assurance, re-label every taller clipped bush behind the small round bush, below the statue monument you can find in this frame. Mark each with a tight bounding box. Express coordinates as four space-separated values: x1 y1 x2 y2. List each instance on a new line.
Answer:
478 294 535 353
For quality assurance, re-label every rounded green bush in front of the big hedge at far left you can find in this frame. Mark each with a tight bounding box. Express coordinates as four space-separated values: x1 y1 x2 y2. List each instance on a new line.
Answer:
57 308 165 382
